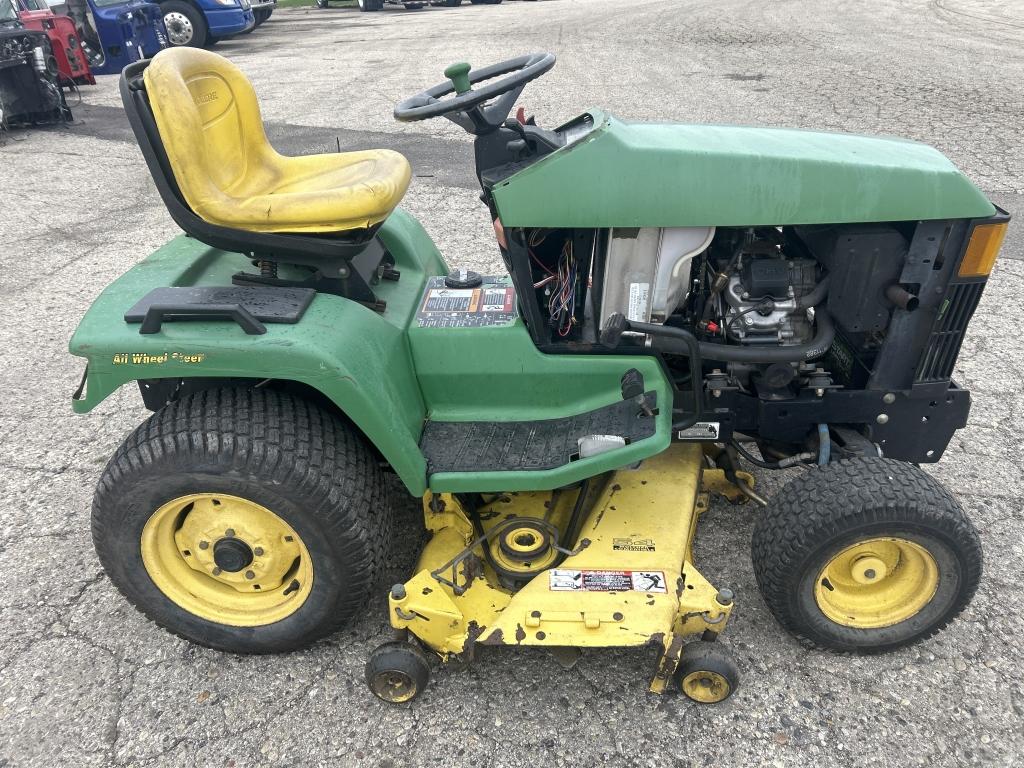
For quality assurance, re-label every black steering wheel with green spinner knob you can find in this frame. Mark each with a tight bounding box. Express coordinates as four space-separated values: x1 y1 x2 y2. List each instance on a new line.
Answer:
394 53 555 135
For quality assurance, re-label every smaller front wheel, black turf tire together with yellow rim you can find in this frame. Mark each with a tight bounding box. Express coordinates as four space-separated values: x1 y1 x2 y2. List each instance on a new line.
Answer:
753 459 982 653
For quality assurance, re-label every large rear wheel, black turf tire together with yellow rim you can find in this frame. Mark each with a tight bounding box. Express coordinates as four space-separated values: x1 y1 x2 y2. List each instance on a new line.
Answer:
92 388 391 653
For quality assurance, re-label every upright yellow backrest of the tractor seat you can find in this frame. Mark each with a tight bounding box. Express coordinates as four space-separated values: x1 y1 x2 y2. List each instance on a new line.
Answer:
143 48 273 218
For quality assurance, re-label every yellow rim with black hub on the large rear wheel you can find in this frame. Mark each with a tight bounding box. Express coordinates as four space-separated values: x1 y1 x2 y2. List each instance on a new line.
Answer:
141 494 313 627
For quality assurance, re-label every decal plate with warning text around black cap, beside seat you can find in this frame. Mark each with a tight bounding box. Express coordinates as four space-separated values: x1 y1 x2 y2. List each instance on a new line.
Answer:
416 278 516 328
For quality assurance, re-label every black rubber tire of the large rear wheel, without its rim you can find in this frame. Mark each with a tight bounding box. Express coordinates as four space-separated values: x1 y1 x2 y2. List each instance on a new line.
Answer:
92 388 392 653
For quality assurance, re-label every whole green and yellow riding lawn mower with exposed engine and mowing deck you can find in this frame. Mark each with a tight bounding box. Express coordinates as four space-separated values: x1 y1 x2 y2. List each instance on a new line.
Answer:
71 48 1009 702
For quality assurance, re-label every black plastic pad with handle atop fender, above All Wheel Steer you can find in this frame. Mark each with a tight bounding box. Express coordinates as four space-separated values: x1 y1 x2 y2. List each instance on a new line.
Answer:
125 286 316 324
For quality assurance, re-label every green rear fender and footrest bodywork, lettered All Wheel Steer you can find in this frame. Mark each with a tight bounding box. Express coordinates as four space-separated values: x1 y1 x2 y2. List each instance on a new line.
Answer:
71 210 672 496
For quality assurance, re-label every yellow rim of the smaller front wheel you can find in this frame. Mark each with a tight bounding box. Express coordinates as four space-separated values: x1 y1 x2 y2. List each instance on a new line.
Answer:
814 538 939 630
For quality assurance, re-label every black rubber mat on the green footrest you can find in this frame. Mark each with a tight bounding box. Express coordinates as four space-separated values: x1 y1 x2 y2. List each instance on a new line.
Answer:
420 392 657 474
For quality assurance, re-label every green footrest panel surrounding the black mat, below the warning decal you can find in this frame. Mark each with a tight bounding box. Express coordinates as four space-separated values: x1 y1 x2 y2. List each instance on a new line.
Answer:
409 319 672 493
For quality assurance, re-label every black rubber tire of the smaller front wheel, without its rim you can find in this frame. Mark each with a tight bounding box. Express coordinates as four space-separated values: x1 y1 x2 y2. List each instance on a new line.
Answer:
752 458 982 653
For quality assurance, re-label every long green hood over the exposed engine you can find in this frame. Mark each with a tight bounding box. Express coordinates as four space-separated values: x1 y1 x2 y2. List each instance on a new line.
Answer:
494 111 995 227
